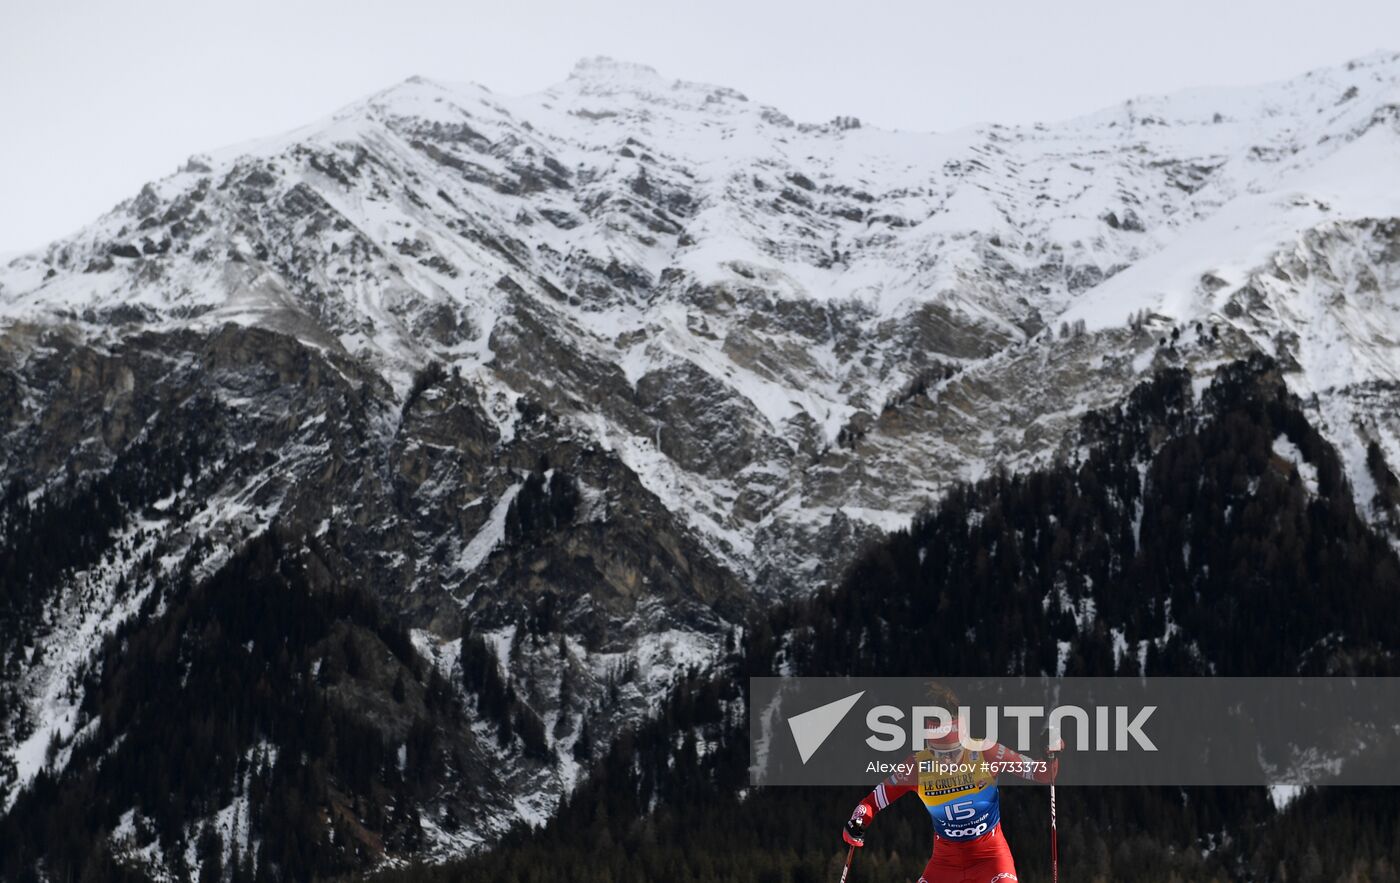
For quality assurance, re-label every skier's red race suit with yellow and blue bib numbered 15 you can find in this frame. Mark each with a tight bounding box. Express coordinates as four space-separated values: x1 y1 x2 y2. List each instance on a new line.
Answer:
851 742 1058 883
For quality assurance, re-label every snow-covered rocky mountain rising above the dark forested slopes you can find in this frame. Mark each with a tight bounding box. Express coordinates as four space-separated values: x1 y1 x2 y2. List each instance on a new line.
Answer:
0 53 1400 878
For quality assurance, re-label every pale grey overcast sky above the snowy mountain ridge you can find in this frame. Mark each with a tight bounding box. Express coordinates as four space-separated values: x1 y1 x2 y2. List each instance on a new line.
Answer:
0 0 1400 253
